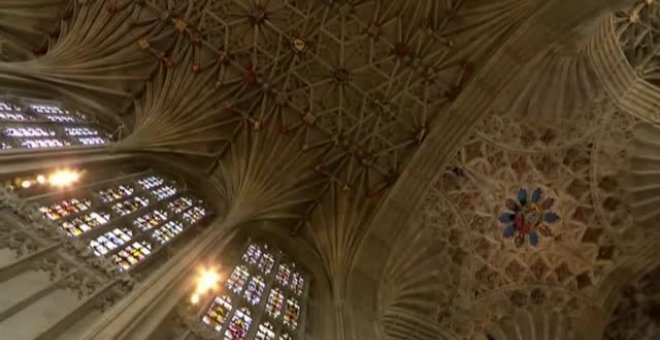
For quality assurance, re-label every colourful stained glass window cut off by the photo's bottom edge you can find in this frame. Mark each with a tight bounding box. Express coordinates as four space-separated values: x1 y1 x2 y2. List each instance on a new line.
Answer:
195 243 308 340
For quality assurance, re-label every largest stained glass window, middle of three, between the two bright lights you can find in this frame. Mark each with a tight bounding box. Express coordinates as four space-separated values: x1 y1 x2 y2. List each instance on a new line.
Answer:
25 166 209 271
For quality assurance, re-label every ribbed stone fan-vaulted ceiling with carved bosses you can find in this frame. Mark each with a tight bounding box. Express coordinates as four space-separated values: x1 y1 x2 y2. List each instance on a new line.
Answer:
0 0 660 339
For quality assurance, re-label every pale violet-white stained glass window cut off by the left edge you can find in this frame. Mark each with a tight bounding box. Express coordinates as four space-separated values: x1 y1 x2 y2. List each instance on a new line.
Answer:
0 97 111 149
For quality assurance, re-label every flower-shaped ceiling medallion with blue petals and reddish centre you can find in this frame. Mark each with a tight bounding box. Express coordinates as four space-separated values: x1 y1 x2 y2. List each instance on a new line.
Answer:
498 188 560 247
